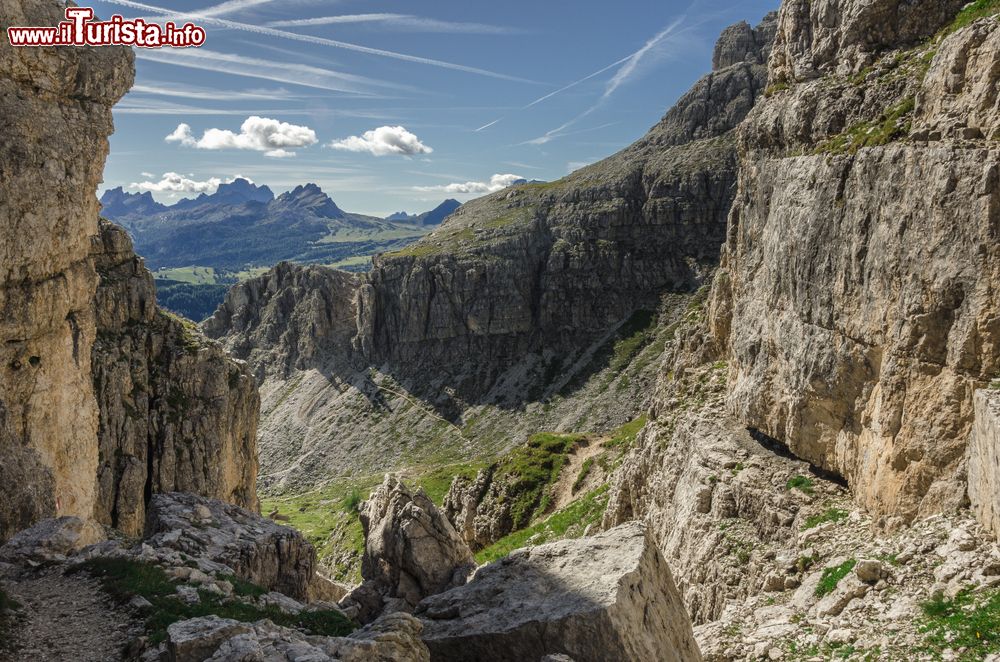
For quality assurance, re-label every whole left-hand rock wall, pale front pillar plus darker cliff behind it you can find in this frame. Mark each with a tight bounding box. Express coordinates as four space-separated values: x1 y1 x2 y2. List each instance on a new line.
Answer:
0 0 258 540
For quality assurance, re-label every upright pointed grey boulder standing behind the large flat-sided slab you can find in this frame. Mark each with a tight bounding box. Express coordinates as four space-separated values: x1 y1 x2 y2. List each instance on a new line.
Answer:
345 475 476 622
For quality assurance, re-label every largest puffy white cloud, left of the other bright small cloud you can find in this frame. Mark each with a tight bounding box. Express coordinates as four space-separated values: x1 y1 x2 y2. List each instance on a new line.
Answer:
164 115 316 158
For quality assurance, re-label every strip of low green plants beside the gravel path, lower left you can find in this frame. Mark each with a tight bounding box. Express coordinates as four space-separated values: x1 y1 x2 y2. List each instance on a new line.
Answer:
75 558 355 644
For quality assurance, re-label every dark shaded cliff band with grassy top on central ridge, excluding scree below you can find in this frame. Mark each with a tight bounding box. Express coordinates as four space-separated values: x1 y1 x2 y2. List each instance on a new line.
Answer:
356 16 774 392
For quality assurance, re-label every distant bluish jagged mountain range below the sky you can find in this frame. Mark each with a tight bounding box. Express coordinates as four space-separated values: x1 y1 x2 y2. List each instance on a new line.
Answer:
101 179 460 272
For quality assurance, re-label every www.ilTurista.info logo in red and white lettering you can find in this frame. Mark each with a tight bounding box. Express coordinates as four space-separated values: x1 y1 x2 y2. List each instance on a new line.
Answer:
7 7 205 48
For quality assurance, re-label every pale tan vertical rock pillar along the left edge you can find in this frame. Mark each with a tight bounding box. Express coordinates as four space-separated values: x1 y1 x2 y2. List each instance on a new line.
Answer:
0 0 133 540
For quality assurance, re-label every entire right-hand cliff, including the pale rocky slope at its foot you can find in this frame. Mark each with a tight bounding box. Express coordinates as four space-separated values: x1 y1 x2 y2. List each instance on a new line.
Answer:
605 0 1000 632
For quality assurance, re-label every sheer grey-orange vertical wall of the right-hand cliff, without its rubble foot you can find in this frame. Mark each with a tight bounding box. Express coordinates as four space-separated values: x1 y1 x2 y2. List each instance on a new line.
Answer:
709 2 1000 524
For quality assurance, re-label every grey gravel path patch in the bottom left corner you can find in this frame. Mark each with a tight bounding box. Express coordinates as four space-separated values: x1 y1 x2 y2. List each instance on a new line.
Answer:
0 570 141 662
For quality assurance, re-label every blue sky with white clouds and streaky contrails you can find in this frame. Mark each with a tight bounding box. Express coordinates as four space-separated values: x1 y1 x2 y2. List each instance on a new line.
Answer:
94 0 778 216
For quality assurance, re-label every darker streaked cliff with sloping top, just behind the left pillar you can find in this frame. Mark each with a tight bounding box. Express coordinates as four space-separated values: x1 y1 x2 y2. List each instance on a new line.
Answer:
92 221 260 535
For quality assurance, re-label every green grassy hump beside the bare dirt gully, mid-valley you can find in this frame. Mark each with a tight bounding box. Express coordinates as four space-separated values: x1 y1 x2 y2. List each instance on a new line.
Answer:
494 433 587 530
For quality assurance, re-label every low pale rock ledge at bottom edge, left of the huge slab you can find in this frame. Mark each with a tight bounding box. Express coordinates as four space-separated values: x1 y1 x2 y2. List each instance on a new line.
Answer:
167 613 430 662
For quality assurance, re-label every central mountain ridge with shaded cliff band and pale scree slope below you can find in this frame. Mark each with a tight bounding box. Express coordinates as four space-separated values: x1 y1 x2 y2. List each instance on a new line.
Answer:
204 15 776 496
